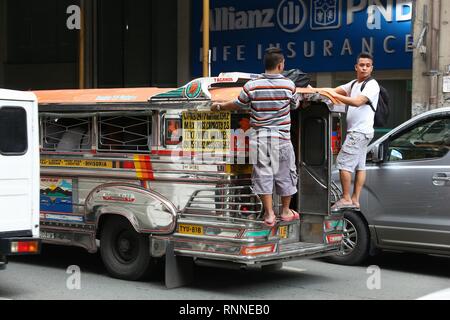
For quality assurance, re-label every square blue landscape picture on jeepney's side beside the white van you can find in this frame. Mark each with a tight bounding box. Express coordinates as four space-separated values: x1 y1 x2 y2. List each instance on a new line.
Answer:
40 178 73 214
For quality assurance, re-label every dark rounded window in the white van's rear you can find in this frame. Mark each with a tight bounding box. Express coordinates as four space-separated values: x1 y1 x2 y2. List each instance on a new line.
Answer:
0 107 28 155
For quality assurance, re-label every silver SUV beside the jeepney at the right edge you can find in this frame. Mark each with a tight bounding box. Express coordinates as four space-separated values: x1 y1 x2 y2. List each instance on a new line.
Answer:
331 108 450 265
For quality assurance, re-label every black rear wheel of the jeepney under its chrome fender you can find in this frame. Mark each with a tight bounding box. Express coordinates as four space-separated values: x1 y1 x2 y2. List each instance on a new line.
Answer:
100 217 153 281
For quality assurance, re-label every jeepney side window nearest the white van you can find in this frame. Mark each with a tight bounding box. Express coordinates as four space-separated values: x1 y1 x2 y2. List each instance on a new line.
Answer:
42 115 92 152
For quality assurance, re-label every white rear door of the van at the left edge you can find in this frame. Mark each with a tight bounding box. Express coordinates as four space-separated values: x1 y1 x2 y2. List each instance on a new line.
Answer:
0 90 39 238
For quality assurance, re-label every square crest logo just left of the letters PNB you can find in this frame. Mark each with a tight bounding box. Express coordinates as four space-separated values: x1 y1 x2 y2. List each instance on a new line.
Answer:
311 0 342 30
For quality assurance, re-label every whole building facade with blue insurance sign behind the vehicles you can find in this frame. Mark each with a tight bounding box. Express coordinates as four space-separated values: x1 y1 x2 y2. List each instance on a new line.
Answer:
0 0 450 127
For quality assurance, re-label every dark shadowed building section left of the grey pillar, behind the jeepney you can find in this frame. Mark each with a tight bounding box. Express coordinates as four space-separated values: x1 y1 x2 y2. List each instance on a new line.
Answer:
0 0 178 90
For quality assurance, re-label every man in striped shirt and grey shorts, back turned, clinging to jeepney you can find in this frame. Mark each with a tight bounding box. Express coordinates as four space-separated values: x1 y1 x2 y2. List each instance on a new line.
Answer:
211 48 299 227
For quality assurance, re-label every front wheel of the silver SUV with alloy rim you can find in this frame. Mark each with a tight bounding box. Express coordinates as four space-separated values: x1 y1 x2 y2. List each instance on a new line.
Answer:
327 211 370 265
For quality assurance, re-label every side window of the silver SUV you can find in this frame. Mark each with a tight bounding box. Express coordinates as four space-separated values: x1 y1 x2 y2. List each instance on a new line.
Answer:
387 117 450 162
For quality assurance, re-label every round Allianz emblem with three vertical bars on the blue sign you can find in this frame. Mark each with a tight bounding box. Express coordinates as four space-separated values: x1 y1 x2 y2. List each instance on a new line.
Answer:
277 0 308 33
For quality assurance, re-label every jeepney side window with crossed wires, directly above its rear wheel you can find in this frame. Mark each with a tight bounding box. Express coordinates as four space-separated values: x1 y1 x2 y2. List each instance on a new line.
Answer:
98 114 152 152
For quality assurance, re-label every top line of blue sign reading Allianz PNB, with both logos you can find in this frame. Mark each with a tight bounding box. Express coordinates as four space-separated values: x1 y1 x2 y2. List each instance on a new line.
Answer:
206 0 412 33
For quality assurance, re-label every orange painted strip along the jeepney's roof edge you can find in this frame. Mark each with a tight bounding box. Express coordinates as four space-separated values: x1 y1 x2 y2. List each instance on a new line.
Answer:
34 88 172 104
